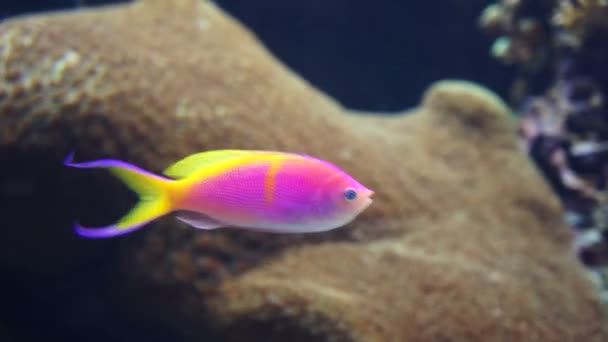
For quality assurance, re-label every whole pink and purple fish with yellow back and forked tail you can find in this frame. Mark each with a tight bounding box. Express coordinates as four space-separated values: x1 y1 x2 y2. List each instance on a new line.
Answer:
65 150 374 238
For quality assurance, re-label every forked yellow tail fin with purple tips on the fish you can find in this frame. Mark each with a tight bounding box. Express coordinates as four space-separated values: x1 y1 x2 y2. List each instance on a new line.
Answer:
64 154 173 238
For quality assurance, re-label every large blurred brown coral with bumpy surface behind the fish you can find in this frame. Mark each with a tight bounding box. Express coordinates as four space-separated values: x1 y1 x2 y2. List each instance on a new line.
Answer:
0 0 608 341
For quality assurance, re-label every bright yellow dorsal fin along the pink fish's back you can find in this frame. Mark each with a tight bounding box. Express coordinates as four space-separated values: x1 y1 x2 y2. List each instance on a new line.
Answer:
163 150 261 179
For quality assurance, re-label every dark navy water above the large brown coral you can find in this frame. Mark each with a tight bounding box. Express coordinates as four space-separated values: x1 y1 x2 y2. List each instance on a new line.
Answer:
0 0 513 111
